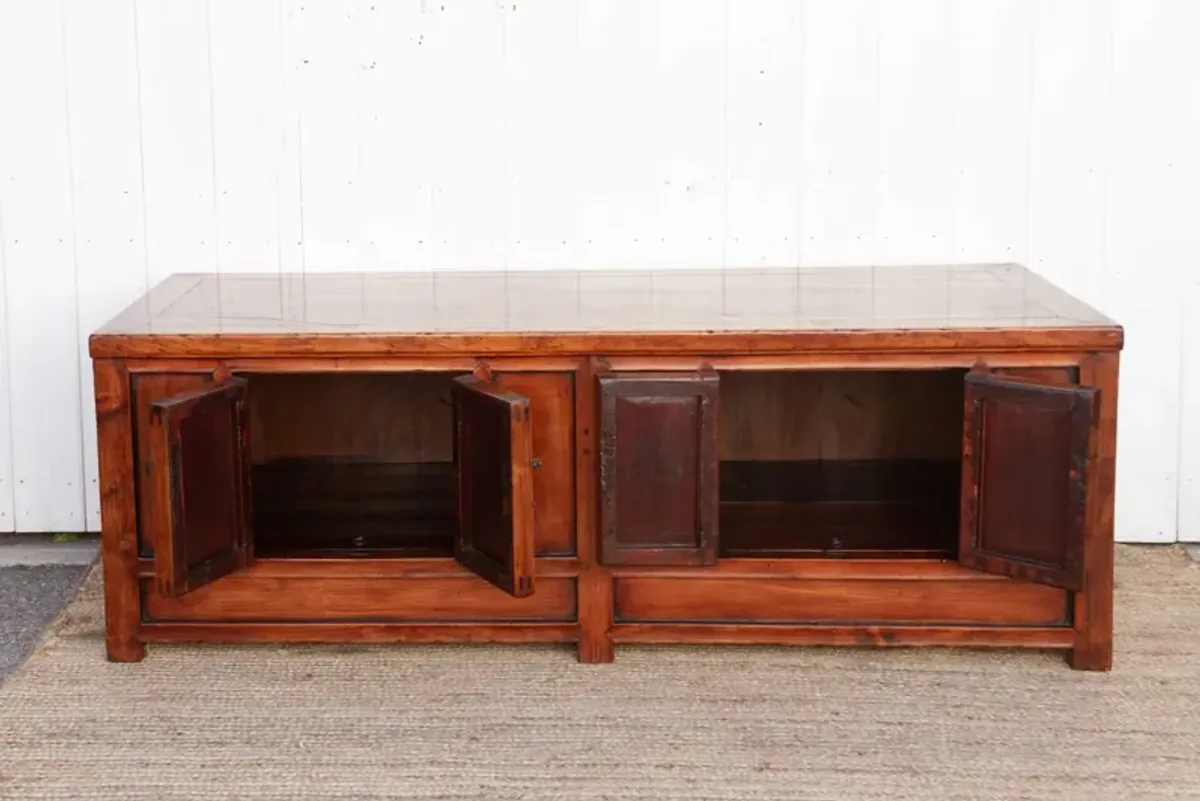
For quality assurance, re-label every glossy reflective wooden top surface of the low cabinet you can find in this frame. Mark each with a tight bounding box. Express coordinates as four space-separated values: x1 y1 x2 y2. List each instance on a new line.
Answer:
96 264 1116 337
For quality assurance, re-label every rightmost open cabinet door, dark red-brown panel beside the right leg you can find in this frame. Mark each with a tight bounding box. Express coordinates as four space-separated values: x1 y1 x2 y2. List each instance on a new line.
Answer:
959 373 1096 590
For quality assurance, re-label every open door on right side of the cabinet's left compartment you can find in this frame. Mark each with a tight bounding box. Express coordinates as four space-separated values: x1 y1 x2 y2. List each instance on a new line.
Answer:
454 375 534 598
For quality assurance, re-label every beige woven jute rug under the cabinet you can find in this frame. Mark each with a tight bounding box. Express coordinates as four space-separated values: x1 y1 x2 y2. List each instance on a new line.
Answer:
0 547 1200 801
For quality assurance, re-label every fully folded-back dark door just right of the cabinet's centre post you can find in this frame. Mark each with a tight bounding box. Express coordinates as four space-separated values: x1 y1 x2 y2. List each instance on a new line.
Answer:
599 373 719 565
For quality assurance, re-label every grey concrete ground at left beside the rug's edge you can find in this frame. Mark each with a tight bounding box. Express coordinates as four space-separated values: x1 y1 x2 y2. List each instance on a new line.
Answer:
0 535 98 681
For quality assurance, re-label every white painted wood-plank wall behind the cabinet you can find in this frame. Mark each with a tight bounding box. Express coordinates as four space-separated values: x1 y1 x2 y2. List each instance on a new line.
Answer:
0 0 1200 541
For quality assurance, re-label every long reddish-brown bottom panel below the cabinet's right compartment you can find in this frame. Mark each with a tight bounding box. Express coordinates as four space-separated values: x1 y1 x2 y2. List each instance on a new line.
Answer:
616 577 1070 628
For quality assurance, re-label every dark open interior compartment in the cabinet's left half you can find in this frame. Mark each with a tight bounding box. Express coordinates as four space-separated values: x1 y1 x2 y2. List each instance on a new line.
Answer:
246 373 461 556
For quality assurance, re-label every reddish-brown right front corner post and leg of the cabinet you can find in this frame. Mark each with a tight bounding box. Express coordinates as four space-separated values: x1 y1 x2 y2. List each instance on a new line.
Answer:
1070 353 1120 670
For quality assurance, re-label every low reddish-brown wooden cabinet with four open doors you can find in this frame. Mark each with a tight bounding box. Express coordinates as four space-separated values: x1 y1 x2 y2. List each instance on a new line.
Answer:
90 265 1122 669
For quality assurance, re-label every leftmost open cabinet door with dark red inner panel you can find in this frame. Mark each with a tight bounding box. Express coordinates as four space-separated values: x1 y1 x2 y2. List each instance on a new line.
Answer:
148 379 251 596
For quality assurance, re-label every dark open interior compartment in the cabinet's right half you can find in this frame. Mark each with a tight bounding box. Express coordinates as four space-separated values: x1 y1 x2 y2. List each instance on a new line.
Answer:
720 369 965 558
